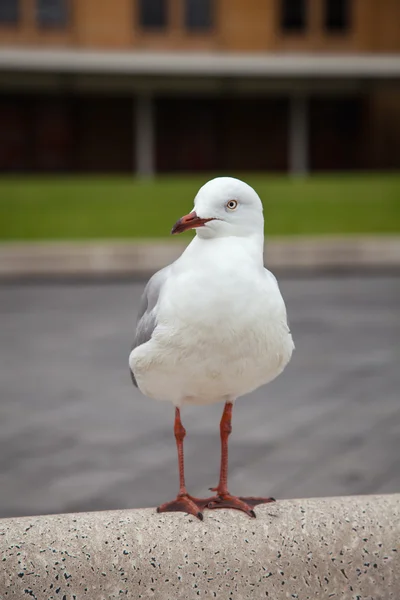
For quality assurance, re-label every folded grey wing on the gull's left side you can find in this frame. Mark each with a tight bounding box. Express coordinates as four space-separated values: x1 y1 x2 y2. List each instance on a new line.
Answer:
131 265 171 387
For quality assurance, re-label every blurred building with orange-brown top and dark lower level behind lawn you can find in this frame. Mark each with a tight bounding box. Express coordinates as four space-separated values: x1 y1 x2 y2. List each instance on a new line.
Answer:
0 0 400 175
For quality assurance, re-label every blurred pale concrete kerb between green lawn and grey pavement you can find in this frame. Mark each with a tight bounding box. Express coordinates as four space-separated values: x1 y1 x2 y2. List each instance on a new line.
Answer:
0 236 400 279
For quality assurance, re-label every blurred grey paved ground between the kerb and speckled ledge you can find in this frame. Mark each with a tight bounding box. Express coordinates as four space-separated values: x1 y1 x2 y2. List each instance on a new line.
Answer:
0 277 400 516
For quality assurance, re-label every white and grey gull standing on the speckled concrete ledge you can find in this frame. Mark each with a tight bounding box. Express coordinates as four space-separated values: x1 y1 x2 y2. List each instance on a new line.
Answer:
129 177 294 519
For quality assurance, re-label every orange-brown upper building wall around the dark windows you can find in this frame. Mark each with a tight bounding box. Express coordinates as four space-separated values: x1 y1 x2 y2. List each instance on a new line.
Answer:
0 0 400 52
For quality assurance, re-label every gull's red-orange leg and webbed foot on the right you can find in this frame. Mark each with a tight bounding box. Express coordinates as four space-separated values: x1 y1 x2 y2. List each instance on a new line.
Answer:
204 402 274 517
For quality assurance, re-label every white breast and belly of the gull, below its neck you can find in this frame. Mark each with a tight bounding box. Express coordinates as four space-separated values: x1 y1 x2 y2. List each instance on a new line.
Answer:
130 241 294 404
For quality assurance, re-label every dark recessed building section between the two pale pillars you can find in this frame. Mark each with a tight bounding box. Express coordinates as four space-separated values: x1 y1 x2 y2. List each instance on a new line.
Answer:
156 98 288 172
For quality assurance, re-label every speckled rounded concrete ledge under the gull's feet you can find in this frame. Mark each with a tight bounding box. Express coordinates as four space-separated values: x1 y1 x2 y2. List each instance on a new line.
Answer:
0 494 400 600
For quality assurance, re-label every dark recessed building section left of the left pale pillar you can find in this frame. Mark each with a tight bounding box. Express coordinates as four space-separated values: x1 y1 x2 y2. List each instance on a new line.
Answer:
0 96 134 173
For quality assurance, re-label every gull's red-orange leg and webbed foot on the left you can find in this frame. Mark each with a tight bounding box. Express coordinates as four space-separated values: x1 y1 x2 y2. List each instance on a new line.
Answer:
157 408 203 520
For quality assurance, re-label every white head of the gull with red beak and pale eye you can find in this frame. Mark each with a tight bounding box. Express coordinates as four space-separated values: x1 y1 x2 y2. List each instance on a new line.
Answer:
171 177 264 238
